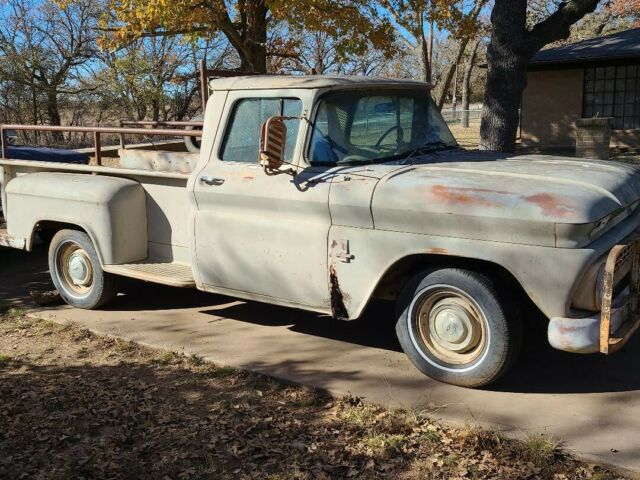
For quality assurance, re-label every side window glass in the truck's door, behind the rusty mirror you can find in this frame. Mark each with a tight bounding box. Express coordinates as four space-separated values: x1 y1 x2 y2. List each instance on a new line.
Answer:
220 98 302 163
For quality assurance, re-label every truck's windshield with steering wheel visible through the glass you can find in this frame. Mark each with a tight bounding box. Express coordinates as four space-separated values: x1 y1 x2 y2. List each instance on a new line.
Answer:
309 92 457 165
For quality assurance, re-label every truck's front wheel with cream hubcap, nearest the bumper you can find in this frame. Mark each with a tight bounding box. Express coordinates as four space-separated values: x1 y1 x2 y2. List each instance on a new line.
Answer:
396 268 522 387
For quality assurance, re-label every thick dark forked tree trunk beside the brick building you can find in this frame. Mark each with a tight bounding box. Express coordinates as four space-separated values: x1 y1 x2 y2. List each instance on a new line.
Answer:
480 0 600 152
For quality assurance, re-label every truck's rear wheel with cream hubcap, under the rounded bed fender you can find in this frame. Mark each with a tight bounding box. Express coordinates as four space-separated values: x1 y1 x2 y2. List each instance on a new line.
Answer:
49 230 118 310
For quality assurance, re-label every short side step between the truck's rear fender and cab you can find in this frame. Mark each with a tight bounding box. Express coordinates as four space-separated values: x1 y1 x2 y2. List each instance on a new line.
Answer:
102 260 196 288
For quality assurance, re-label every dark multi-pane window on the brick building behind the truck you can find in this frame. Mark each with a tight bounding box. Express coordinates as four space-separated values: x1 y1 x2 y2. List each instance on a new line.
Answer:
582 65 640 129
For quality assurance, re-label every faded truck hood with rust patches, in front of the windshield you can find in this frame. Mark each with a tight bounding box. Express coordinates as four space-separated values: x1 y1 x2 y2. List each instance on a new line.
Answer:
372 152 640 248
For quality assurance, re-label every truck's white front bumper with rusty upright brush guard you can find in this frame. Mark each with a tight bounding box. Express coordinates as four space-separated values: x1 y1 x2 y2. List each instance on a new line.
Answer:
548 240 640 355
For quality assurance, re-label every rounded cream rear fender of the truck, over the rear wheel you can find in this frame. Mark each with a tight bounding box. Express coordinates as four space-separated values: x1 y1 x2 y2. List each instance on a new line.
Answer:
6 172 148 265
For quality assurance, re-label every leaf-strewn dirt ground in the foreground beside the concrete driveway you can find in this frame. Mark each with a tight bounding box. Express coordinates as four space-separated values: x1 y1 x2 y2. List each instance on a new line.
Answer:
0 309 623 480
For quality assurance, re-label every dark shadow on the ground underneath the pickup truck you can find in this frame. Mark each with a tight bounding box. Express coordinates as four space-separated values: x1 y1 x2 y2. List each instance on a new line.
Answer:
0 249 640 394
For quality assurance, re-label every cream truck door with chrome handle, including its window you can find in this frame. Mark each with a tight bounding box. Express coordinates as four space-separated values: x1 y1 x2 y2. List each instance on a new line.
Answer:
194 91 331 311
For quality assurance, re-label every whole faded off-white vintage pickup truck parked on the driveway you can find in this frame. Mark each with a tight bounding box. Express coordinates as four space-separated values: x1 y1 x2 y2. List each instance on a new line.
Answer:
0 76 640 386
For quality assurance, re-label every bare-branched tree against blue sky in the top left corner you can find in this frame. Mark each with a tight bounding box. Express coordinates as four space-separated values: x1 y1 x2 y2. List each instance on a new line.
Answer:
0 0 97 129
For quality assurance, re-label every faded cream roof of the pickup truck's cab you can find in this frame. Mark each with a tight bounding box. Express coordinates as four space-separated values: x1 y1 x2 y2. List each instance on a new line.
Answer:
209 75 431 90
